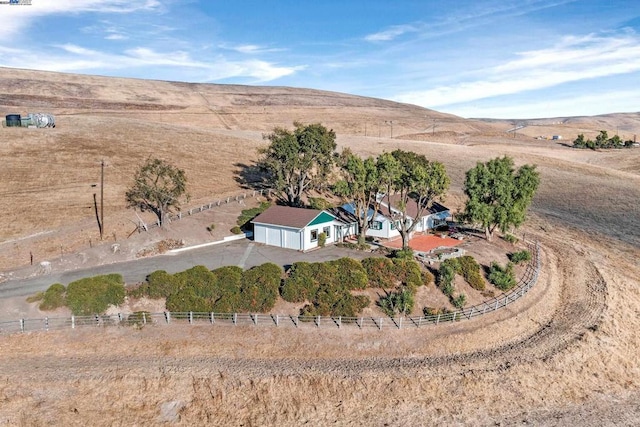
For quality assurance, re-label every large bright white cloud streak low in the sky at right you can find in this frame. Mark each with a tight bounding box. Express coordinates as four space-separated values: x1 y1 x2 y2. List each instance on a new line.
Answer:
395 32 640 107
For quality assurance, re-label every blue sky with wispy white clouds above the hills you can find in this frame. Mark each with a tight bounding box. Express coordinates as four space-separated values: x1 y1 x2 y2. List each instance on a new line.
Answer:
0 0 640 119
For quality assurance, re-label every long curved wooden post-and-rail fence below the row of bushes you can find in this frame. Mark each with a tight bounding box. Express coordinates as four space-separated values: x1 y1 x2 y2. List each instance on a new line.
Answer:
0 242 541 334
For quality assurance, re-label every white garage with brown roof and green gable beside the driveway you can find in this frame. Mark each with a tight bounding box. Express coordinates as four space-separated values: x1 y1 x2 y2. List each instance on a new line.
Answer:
251 206 352 251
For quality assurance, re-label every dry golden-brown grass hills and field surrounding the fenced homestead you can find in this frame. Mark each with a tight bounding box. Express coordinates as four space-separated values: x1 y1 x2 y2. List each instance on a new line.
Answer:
0 69 640 426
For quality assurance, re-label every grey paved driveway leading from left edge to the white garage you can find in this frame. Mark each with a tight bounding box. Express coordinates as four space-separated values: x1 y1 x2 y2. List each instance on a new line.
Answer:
0 240 371 298
